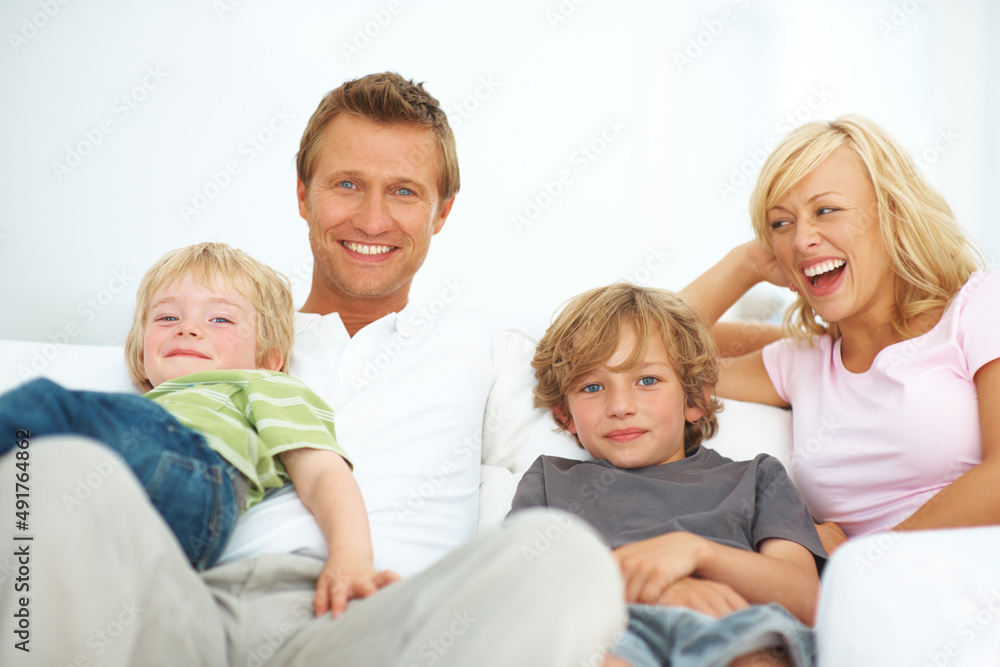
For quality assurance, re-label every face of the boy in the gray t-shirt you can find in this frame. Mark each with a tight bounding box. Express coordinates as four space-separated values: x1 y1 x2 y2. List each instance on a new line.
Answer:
566 329 703 468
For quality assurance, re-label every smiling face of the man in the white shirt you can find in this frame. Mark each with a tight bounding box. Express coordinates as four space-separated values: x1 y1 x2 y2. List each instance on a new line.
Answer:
298 113 452 310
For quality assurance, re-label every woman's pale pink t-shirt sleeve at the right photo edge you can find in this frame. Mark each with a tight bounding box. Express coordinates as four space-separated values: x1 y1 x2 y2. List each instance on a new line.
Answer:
956 271 1000 377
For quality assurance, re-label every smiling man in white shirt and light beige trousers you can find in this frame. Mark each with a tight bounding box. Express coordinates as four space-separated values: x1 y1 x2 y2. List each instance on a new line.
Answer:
0 74 624 667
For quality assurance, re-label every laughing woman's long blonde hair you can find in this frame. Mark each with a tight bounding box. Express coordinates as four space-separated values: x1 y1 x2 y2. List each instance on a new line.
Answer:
750 114 983 340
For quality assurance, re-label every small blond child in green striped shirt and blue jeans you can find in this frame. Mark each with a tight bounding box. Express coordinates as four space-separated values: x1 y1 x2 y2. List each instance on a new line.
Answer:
0 243 398 617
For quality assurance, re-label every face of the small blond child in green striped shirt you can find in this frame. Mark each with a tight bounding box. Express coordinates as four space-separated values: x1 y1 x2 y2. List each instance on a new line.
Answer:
143 275 280 386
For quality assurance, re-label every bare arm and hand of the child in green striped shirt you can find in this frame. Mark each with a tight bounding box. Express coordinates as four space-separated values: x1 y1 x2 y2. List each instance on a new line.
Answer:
278 449 399 618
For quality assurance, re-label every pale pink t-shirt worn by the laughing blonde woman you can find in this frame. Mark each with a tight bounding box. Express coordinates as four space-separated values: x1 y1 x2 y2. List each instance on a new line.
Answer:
763 272 1000 537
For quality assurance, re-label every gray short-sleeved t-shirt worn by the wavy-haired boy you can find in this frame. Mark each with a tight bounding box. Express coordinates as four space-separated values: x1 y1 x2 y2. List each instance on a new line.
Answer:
511 447 826 558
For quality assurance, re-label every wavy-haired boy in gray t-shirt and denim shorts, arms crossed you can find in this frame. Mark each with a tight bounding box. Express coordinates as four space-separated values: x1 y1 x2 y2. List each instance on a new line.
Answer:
511 283 826 667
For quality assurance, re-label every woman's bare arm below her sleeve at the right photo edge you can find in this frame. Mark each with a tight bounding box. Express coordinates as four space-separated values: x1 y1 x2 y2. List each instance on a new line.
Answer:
896 359 1000 530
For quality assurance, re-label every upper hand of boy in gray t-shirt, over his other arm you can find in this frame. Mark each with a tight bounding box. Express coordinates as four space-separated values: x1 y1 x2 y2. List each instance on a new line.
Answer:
612 532 711 604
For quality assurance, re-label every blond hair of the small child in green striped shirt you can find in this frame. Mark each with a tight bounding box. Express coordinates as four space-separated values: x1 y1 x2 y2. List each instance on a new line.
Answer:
125 243 295 391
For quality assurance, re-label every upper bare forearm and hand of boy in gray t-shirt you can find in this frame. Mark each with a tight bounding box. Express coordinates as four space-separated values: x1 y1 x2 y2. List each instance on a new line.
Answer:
614 532 819 625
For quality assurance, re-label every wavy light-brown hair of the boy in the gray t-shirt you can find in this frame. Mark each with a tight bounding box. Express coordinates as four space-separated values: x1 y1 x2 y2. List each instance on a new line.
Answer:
531 282 722 453
